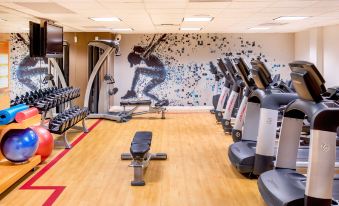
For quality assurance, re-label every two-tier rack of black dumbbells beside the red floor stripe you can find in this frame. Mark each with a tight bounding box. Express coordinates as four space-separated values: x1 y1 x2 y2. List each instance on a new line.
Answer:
36 88 88 149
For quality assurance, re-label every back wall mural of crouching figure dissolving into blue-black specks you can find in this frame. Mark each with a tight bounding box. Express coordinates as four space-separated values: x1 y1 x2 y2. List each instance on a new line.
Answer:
114 34 294 106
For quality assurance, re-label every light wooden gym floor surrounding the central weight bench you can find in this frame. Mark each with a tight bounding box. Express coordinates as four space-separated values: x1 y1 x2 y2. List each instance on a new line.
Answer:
0 113 264 206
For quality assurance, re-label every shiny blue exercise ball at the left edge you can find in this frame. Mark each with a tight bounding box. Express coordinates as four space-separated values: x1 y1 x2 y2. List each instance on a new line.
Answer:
0 128 39 163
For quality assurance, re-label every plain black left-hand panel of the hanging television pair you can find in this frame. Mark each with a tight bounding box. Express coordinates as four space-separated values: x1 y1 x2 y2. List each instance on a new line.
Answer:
29 21 45 57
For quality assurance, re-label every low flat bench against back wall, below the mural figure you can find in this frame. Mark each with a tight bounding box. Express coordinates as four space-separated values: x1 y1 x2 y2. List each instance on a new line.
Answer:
120 100 169 119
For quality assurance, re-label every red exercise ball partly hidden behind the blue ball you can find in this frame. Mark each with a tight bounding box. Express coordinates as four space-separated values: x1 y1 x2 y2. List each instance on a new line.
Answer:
31 126 54 162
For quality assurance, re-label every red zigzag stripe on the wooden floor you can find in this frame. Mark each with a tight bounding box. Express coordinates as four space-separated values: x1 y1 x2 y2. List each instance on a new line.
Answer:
19 120 101 206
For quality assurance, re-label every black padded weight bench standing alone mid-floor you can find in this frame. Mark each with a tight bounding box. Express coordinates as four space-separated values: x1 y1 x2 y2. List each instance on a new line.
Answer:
121 131 167 186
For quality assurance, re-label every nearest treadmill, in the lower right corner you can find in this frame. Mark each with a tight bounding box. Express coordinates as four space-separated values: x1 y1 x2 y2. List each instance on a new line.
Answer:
258 61 339 206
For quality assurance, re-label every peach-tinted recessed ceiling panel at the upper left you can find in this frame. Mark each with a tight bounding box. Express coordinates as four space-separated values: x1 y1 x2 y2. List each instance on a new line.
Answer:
15 2 75 14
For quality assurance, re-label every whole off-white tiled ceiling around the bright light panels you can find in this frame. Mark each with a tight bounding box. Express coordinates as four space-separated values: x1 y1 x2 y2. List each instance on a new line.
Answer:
0 0 339 33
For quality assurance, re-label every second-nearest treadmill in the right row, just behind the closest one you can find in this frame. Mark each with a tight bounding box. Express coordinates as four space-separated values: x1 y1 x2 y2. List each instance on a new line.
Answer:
228 60 298 175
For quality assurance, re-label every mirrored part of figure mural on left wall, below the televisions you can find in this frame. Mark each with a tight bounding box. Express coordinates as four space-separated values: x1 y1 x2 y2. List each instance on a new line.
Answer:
10 33 48 99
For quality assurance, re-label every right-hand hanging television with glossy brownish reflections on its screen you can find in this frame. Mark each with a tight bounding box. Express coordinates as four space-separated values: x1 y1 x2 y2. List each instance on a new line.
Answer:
44 22 63 58
